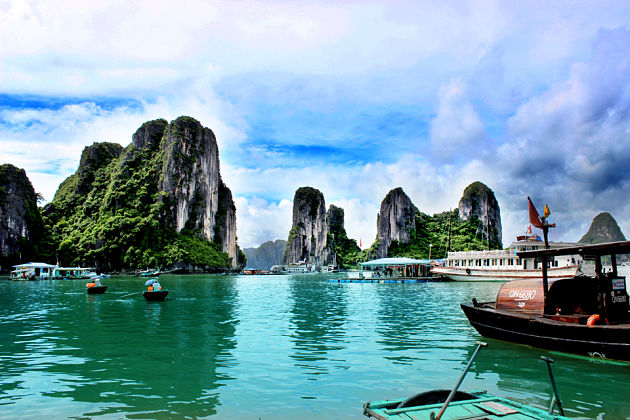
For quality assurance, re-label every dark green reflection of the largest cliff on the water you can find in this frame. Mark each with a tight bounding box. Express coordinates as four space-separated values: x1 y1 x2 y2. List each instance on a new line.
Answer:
0 278 237 417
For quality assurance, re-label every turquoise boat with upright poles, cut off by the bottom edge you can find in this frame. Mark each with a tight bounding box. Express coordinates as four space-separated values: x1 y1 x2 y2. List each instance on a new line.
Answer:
363 343 568 420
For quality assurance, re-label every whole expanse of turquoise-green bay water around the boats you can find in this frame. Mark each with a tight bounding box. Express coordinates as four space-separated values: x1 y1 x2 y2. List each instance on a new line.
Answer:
0 275 630 419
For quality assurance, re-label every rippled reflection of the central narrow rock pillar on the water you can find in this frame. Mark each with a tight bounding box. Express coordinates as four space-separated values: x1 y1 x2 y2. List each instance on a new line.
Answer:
290 276 348 375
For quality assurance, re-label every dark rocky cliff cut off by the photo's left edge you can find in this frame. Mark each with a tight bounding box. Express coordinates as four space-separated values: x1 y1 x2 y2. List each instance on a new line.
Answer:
0 164 43 270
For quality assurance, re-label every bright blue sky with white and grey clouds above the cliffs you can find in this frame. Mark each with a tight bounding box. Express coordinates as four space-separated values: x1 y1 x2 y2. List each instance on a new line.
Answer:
0 0 630 248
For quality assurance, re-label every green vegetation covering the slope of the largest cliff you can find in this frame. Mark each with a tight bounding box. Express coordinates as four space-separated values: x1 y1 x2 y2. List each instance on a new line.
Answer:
43 117 237 271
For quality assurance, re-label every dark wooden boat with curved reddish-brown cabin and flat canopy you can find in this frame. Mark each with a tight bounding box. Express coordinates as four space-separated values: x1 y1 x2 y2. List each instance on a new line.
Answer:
461 241 630 360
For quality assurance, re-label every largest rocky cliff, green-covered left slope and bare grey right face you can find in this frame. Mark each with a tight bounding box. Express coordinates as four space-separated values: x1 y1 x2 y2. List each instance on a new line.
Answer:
45 117 245 271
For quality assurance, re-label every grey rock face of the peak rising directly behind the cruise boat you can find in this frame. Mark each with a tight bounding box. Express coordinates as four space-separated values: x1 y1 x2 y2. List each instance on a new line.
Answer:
458 182 503 249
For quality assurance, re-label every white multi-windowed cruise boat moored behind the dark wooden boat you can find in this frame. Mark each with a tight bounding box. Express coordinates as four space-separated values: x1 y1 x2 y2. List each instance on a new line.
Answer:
431 235 583 281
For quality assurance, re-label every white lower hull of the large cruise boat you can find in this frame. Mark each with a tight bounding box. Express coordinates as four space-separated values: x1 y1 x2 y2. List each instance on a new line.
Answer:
431 265 579 281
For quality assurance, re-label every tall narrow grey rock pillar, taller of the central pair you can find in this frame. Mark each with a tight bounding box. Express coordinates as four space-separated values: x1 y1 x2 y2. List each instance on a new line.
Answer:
282 187 331 267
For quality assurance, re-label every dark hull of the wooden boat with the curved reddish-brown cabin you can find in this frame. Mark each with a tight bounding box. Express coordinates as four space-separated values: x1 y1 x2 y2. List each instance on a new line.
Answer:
461 304 630 361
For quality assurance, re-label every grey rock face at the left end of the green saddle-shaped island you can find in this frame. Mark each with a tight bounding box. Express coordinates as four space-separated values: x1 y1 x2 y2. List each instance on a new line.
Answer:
374 187 416 258
